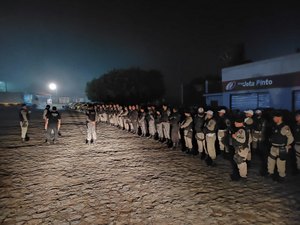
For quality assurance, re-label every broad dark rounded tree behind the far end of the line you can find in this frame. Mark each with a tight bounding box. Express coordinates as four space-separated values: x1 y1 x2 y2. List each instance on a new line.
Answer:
86 68 165 104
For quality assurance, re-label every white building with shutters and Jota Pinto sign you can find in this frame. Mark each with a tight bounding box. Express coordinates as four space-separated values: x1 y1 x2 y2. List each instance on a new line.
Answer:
206 53 300 110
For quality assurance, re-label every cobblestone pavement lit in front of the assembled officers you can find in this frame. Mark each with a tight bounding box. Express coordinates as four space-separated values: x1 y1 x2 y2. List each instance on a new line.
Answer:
0 110 300 225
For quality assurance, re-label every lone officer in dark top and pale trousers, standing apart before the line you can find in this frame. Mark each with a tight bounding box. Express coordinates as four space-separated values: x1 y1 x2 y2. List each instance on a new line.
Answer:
86 104 97 145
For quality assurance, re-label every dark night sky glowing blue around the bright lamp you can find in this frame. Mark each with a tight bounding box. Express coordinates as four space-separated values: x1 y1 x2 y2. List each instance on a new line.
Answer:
0 0 300 101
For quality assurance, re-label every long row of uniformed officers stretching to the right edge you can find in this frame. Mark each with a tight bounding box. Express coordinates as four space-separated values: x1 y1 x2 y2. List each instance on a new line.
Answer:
86 104 300 182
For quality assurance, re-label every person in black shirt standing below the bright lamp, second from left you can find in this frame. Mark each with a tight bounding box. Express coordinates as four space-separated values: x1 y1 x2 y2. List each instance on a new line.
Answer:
45 106 61 144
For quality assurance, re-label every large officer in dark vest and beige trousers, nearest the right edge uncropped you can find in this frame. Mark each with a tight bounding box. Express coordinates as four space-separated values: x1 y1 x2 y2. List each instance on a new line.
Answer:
268 112 294 182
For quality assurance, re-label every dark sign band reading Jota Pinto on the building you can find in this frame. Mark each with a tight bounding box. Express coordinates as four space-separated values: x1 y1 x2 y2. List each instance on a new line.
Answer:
222 72 300 92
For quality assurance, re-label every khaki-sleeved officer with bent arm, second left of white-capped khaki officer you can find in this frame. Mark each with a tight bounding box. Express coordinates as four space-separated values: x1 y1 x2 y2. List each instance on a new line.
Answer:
180 109 193 154
